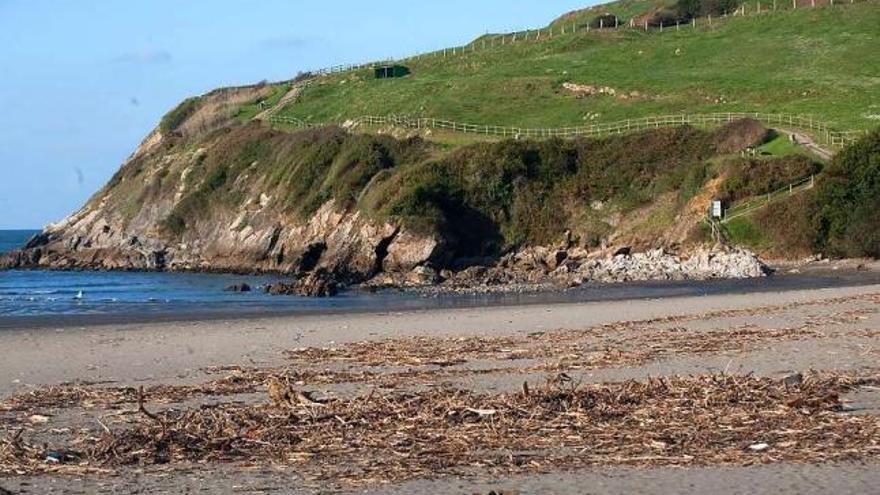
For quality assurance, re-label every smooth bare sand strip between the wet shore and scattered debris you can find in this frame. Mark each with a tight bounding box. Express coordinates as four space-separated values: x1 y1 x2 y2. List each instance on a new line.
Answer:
0 283 880 397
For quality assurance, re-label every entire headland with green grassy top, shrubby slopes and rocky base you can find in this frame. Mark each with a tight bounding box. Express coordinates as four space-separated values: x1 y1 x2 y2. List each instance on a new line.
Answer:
0 1 880 293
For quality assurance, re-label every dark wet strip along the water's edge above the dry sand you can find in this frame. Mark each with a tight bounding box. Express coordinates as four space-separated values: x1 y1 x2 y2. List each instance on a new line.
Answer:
0 260 880 331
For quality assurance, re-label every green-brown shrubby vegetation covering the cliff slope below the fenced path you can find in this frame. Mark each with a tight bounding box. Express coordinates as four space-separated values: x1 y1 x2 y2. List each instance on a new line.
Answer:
143 118 787 266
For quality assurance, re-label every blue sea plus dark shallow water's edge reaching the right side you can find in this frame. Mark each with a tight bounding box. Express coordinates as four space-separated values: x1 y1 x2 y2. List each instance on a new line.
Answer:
0 230 880 330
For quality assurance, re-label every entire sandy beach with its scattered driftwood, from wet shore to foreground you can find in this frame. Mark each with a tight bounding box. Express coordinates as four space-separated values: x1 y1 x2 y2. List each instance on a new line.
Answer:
0 278 880 495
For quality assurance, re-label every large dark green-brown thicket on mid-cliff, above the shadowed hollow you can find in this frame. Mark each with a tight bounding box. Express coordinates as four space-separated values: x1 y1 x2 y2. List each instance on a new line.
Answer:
366 127 714 255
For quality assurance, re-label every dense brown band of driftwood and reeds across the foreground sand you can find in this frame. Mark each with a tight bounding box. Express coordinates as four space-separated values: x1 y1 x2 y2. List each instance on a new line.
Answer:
0 373 880 484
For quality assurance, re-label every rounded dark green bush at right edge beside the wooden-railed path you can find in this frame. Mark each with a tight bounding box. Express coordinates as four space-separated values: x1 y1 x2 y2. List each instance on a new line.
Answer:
817 129 880 258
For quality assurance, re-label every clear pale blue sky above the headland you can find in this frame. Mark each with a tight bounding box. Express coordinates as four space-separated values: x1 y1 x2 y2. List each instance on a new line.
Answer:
0 0 597 229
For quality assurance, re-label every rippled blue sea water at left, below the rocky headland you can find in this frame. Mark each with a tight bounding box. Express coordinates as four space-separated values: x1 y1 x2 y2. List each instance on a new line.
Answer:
0 230 404 320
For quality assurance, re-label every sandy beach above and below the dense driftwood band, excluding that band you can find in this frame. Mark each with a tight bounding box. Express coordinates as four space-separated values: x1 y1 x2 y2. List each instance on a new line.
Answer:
0 283 880 494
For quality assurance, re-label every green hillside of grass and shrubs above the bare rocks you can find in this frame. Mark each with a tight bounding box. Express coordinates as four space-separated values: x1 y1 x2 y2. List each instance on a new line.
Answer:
132 0 880 259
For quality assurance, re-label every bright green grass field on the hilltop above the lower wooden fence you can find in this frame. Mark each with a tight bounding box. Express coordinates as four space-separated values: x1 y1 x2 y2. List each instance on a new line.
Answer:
279 1 880 129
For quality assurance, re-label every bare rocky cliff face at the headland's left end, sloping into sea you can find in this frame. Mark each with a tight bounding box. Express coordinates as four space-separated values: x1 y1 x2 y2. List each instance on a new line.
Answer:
0 119 440 282
